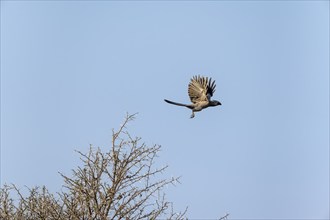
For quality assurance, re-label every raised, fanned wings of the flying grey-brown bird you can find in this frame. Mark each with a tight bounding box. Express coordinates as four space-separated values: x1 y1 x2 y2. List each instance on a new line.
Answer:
188 76 216 103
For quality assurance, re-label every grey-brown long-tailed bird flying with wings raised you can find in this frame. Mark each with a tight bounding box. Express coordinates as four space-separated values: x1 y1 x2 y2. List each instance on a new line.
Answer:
164 75 221 118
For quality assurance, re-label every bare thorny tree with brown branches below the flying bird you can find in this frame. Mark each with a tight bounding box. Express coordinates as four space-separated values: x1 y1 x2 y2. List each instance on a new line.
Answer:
0 115 187 219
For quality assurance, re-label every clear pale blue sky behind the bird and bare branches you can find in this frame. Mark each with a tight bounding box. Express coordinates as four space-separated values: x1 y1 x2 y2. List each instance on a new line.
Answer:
1 1 329 219
